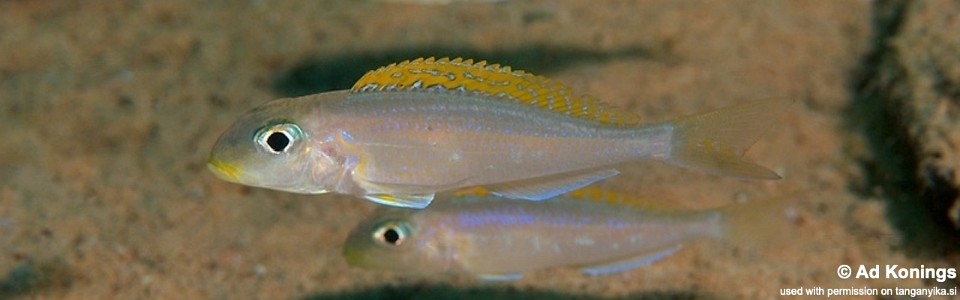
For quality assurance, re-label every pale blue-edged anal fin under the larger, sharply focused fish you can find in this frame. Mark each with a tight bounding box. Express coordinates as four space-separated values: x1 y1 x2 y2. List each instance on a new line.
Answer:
488 169 620 201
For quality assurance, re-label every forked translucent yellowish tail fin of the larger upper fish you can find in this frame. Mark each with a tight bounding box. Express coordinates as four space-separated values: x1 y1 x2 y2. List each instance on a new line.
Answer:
667 98 793 179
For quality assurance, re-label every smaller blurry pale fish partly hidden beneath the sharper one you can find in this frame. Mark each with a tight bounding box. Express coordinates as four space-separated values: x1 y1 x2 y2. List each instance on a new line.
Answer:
343 187 796 280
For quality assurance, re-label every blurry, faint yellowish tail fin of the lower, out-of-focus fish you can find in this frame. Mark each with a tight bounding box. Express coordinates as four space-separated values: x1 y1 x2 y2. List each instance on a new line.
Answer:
719 197 800 248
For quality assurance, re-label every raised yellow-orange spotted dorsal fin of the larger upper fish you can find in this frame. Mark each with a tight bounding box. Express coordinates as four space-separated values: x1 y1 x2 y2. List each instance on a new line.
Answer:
351 57 639 125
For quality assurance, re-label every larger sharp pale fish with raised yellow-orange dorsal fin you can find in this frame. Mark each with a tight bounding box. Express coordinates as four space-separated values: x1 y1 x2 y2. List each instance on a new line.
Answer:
208 58 790 208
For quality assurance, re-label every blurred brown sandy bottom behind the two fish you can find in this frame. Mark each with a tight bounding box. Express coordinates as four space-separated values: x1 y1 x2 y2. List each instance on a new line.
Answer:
0 0 960 299
